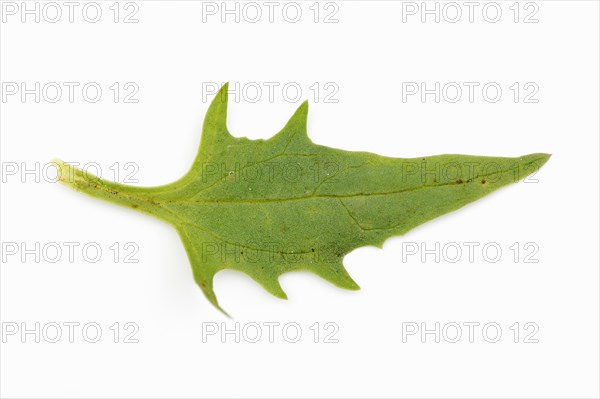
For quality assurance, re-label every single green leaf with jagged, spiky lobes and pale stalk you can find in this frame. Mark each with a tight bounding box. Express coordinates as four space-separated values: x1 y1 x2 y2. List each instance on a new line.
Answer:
57 85 550 316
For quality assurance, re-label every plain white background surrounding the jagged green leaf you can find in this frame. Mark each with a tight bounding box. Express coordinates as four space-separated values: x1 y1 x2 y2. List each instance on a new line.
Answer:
0 1 600 398
